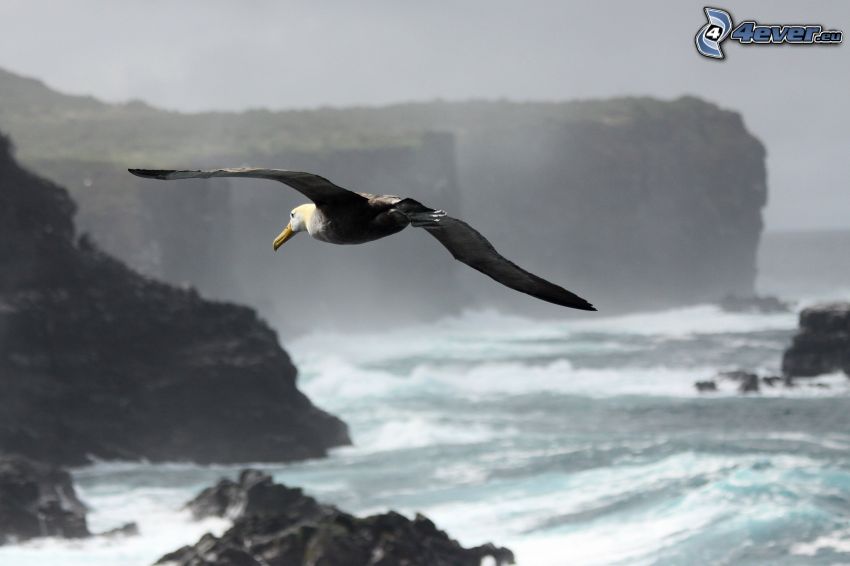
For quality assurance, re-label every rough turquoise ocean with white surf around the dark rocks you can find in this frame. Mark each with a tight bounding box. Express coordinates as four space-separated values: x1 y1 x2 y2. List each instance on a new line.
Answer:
0 232 850 566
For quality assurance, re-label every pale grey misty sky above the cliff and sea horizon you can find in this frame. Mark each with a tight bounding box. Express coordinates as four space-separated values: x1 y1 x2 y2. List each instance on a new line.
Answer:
0 0 850 230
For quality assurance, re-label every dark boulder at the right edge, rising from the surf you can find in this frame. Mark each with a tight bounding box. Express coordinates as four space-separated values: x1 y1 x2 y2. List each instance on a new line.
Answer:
782 303 850 377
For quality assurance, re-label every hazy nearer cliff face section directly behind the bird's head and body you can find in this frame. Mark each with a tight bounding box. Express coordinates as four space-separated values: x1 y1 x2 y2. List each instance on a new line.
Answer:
24 133 463 331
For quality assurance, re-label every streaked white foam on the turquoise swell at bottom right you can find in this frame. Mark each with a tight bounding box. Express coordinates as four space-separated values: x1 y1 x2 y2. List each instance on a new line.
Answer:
425 453 837 565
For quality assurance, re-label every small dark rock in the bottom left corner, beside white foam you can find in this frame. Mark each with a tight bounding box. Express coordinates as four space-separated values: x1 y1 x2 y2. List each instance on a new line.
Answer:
0 455 89 544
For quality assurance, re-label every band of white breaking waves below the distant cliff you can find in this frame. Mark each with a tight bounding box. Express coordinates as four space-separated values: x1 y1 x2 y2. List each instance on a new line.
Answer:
291 305 850 411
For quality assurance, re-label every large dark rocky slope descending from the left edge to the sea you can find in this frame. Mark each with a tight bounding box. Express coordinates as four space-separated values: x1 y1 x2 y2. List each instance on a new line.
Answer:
0 132 349 464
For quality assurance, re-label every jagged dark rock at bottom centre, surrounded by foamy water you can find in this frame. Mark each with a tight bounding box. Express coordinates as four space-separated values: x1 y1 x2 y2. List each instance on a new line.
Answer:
157 470 513 566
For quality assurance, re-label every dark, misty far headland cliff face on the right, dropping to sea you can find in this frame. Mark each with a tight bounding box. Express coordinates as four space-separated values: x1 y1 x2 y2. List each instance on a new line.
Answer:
459 98 767 312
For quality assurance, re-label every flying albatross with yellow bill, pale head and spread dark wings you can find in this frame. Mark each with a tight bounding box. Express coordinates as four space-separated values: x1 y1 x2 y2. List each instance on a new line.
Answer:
129 167 596 311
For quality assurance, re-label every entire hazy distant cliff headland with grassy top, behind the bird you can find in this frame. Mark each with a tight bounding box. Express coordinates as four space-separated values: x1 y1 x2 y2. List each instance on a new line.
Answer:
0 72 766 322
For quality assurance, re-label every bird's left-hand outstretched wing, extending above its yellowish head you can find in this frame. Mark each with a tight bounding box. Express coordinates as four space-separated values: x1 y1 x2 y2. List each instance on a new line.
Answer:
128 167 366 207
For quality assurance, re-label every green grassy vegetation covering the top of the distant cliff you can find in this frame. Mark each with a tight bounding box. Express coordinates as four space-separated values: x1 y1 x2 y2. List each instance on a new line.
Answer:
0 69 717 167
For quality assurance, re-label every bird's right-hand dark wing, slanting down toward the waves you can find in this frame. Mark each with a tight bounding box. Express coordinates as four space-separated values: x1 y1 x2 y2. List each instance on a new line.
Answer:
423 216 596 311
